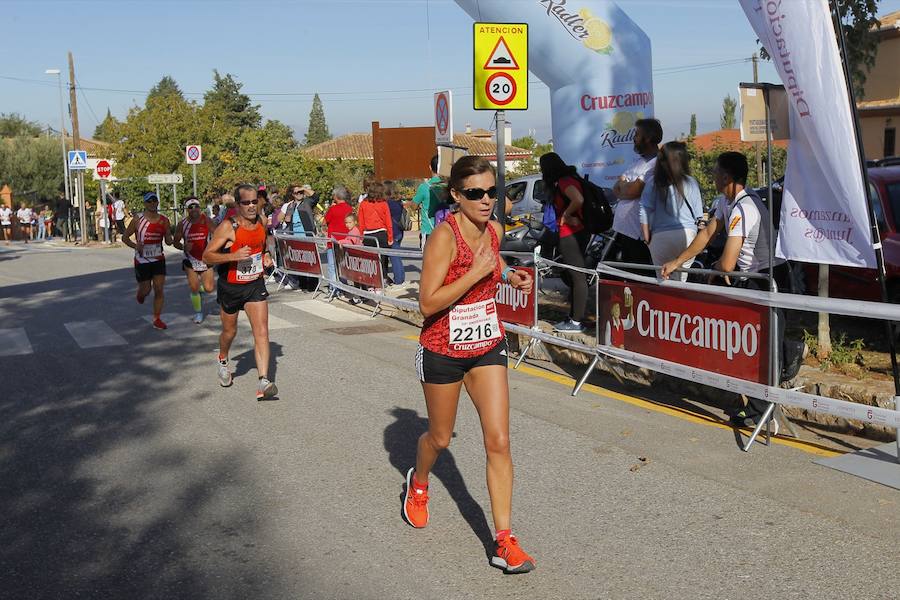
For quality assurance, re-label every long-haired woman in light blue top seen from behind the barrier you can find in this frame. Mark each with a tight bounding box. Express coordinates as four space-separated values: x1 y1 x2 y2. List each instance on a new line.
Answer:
640 142 703 281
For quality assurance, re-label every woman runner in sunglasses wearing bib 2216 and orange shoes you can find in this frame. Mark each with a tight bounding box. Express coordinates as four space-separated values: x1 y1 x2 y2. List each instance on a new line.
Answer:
403 156 535 573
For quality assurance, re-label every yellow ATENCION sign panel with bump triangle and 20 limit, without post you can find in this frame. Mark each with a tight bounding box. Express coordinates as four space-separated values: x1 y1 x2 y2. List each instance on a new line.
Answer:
472 22 528 110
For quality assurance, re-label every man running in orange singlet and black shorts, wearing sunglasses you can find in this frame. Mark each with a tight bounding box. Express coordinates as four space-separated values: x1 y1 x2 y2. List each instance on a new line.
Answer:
203 184 278 400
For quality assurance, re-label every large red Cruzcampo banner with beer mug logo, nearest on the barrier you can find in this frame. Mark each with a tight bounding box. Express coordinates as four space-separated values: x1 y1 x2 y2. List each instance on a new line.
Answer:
598 280 769 383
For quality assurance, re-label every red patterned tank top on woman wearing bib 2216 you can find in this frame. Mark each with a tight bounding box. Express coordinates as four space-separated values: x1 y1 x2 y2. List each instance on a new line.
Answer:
419 215 505 358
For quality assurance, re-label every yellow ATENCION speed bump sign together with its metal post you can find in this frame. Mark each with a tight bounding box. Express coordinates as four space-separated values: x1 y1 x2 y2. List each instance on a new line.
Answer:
472 23 528 228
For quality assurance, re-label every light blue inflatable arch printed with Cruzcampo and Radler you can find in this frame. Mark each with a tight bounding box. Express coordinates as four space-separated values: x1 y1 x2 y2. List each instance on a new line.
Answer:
456 0 653 186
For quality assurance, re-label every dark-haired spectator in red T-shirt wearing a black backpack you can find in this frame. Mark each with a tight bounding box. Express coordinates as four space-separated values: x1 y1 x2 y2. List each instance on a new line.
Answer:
540 152 591 333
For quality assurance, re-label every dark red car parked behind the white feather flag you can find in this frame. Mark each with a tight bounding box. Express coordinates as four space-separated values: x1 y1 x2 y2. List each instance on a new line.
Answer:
806 166 900 304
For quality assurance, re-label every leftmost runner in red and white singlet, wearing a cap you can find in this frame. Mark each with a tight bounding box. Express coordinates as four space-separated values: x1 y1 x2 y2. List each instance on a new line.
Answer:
123 192 172 329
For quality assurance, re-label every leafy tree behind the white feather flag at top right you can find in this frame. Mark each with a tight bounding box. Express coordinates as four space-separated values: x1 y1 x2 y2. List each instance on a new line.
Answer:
760 0 881 98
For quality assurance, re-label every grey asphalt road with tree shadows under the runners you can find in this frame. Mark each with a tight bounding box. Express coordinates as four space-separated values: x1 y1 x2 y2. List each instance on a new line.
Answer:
0 244 900 599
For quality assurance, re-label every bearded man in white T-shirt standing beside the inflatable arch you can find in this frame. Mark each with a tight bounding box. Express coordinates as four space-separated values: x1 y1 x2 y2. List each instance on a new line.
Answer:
613 119 663 265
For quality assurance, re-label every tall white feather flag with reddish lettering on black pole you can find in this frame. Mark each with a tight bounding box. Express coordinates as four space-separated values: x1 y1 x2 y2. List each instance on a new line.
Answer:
740 0 875 267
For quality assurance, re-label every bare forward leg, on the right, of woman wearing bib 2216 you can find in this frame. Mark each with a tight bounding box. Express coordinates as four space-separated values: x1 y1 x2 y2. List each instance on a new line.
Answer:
463 365 513 531
